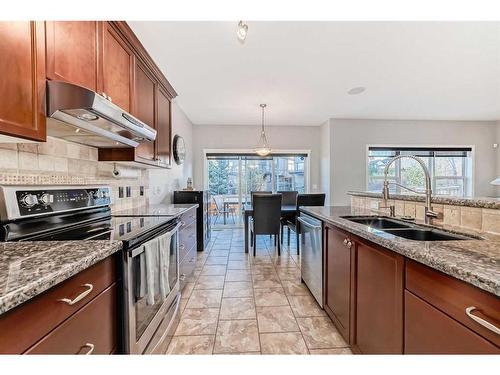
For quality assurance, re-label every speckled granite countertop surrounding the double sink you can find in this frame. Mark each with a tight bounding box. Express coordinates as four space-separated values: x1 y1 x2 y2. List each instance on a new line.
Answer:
300 206 500 296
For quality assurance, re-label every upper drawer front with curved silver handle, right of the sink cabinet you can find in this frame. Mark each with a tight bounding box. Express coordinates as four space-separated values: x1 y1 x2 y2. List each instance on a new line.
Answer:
406 261 500 346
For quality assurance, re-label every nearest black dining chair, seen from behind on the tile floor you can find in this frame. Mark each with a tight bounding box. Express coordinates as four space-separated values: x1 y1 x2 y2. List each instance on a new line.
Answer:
250 194 281 256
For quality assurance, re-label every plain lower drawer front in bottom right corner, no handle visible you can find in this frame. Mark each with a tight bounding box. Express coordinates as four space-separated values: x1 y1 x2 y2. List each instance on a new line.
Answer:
404 290 500 354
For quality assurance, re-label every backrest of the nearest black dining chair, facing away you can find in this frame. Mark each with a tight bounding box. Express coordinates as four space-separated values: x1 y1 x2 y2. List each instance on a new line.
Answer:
253 194 281 234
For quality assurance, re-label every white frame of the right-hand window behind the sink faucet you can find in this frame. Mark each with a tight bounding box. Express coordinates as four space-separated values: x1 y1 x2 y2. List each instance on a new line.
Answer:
365 143 476 197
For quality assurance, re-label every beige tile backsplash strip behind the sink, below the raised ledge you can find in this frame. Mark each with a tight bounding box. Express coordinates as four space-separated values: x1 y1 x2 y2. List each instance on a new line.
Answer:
351 196 500 234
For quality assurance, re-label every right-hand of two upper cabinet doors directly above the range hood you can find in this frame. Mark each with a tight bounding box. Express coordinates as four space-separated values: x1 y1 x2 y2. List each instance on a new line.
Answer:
101 22 134 112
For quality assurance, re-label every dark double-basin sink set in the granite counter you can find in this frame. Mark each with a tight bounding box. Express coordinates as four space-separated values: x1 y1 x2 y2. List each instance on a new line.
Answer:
341 216 480 241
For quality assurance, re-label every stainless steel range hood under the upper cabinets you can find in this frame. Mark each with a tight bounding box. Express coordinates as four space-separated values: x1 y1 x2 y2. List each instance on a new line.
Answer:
47 81 156 148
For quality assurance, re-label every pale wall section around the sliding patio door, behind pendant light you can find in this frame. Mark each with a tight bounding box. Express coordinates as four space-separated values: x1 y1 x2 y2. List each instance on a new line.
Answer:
193 125 321 191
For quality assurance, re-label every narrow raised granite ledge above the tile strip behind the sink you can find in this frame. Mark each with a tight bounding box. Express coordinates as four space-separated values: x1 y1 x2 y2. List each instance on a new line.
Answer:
347 191 500 210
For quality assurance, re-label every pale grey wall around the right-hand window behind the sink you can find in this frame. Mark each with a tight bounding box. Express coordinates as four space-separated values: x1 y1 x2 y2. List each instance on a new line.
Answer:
330 119 500 205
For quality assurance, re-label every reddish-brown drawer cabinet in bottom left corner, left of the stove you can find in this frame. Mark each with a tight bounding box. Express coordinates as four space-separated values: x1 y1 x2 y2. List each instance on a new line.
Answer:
0 256 119 354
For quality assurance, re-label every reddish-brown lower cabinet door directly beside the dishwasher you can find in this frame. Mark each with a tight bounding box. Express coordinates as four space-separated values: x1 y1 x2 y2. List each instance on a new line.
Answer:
325 226 351 342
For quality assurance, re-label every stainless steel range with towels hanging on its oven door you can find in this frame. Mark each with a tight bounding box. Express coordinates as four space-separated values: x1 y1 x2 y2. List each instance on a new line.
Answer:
0 186 180 354
